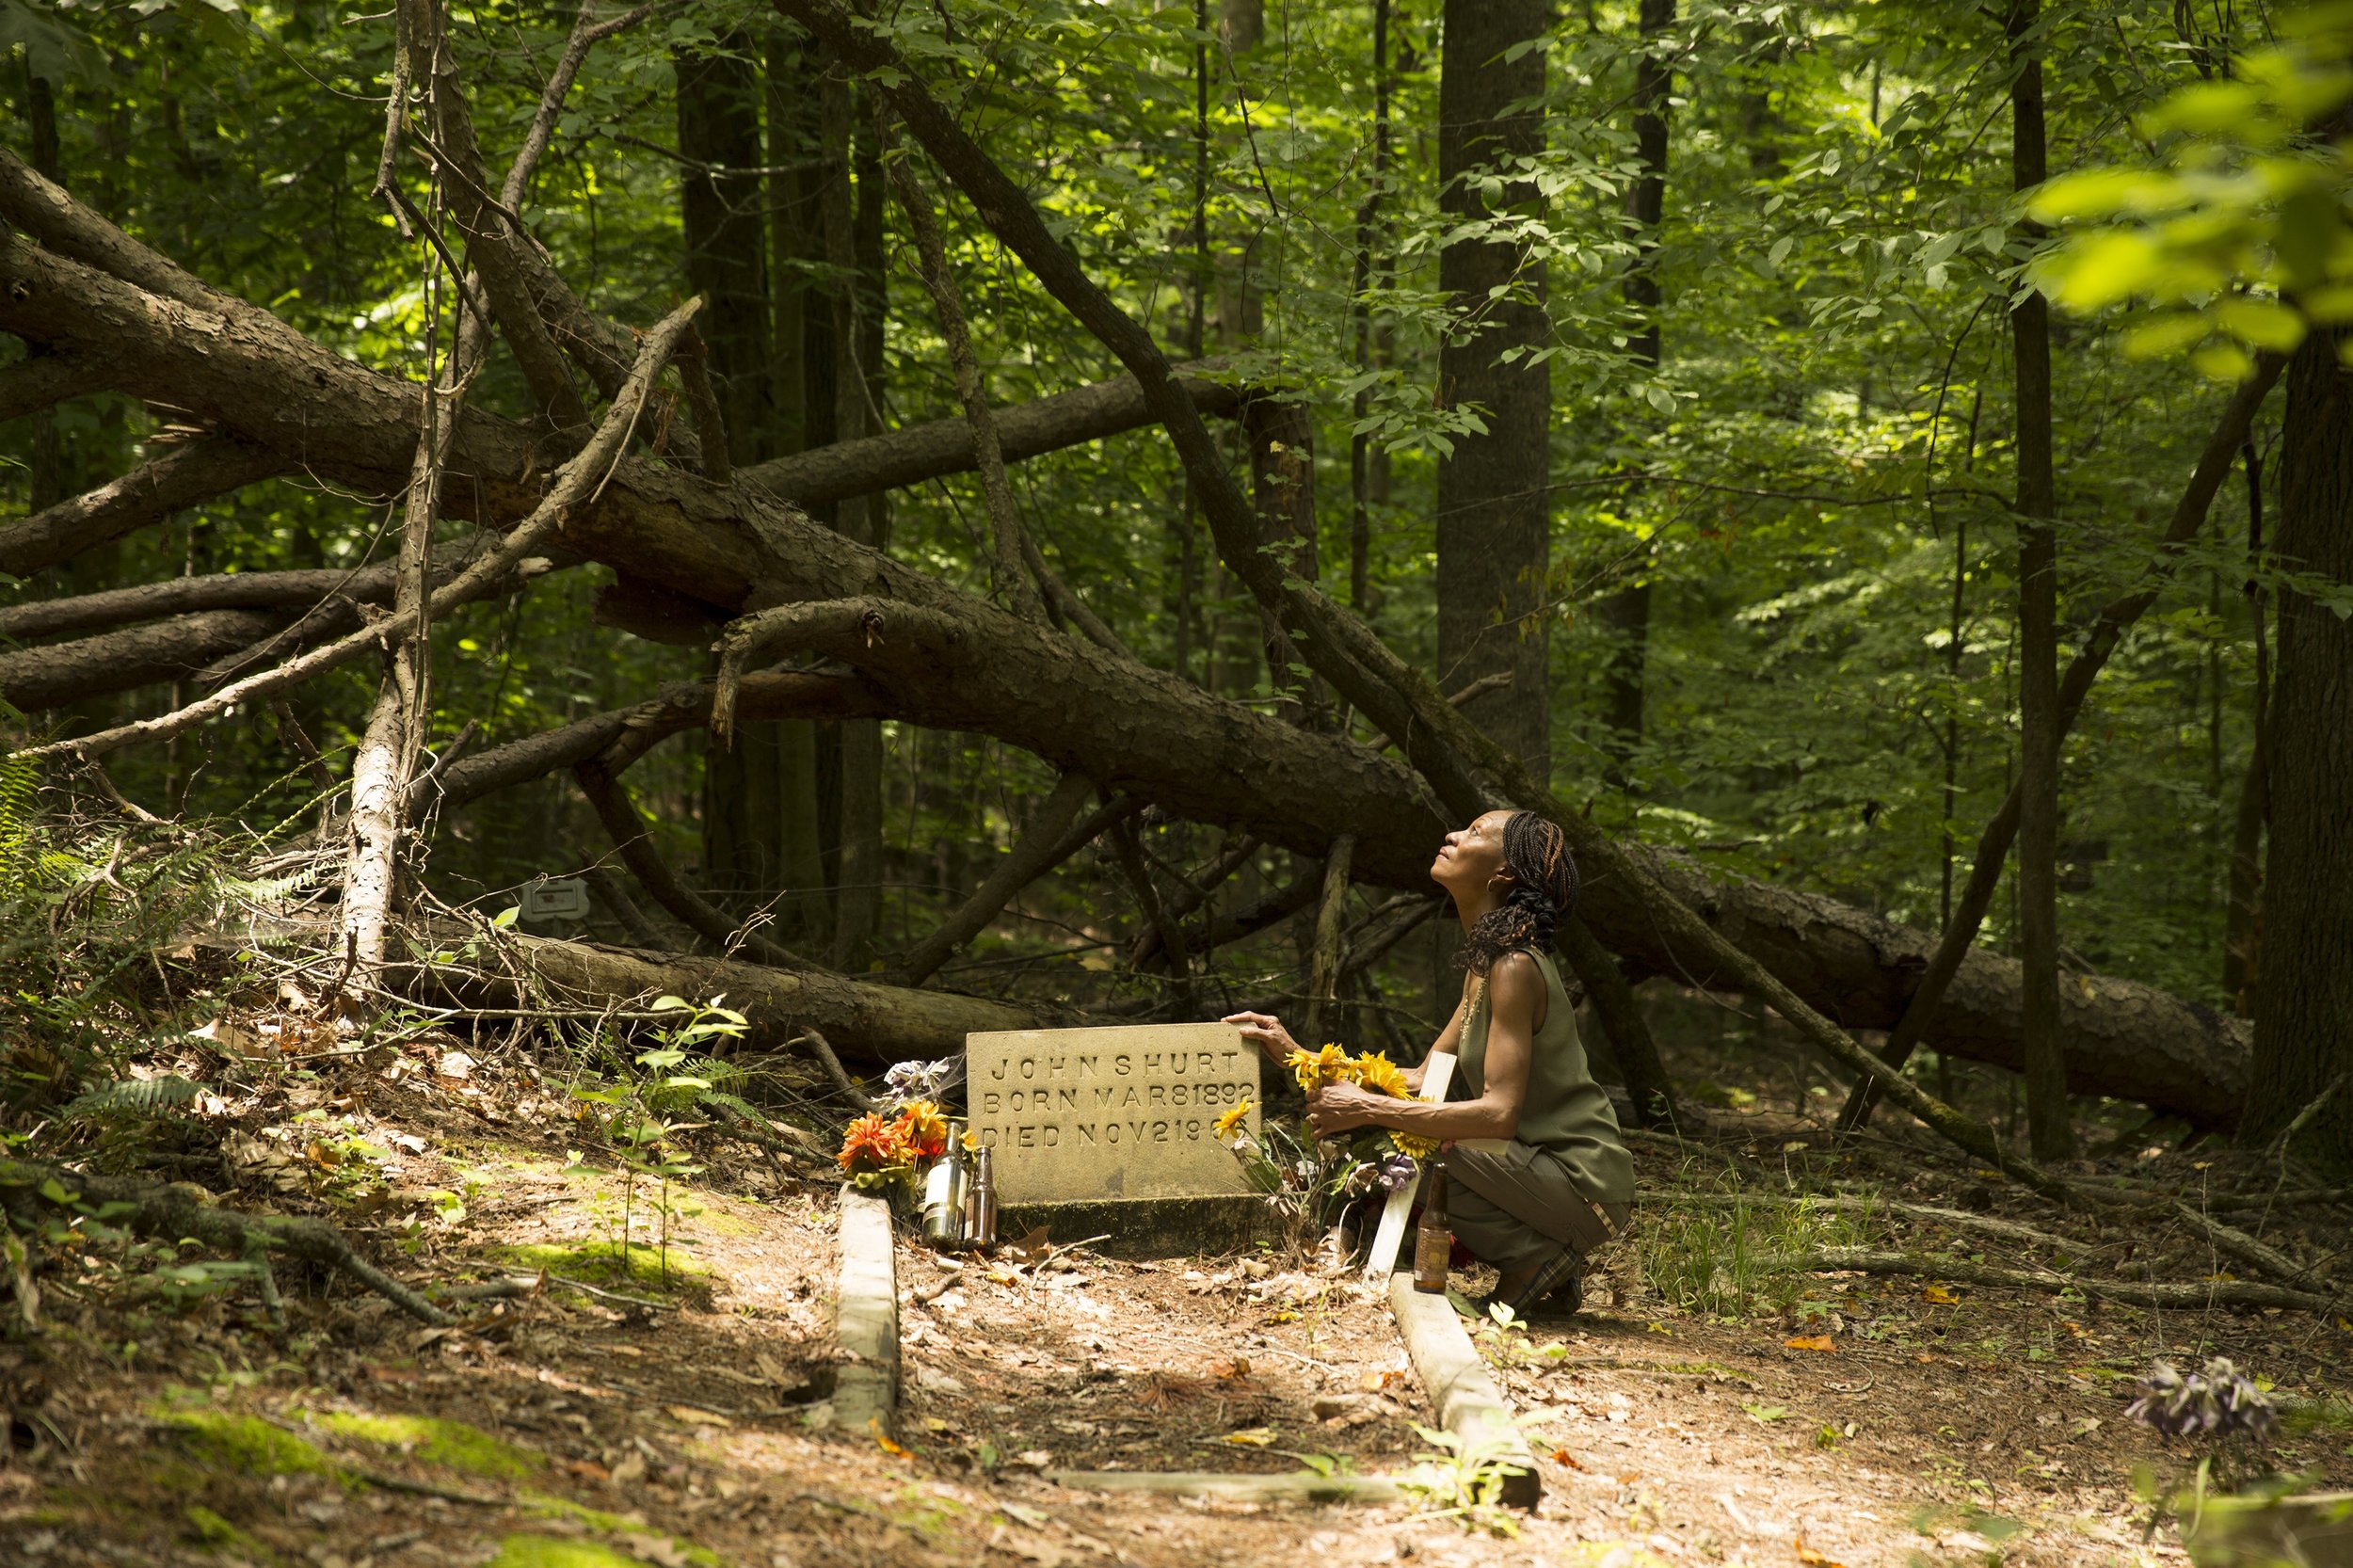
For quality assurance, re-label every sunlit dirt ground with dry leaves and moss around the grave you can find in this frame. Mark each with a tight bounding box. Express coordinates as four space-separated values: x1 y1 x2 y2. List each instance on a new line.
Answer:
0 1012 2353 1568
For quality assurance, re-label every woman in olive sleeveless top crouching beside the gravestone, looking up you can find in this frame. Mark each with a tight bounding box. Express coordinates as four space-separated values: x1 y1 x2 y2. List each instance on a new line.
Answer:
1226 812 1633 1311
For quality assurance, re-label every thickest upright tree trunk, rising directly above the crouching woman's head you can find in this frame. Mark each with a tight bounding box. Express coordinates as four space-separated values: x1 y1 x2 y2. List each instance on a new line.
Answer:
1438 0 1553 776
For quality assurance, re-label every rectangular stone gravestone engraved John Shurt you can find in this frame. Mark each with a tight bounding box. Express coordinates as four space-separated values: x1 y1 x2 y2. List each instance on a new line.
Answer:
965 1024 1264 1245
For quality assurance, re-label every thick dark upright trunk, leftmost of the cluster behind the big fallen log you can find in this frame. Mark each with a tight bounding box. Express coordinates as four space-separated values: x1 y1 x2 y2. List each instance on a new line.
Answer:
678 33 793 906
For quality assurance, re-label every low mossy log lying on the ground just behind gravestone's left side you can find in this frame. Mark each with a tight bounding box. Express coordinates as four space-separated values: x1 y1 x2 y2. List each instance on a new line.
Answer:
400 935 1054 1064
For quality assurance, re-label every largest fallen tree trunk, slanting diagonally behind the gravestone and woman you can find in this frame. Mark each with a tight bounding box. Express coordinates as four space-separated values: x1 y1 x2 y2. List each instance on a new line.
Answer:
0 151 2248 1126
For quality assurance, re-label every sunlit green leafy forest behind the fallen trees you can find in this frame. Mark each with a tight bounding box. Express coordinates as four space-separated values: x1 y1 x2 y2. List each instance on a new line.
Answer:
0 0 2342 1167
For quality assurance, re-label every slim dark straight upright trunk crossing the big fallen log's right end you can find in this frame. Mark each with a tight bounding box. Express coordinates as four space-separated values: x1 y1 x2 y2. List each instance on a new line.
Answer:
2009 0 2075 1160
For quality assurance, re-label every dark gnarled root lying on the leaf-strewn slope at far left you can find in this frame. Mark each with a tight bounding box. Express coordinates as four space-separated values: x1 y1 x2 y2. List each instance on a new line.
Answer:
0 1160 456 1325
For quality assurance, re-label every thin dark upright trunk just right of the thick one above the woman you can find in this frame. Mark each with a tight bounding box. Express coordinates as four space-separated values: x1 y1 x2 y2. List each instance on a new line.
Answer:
1600 0 1675 787
